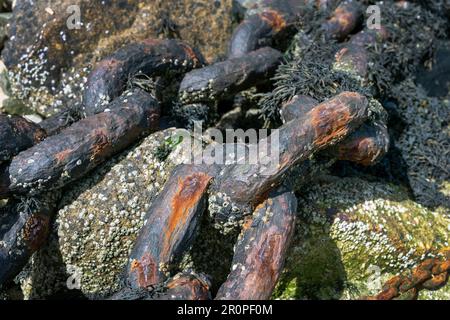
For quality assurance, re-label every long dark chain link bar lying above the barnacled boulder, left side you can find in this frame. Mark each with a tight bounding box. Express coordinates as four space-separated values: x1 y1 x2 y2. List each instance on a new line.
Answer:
0 90 160 196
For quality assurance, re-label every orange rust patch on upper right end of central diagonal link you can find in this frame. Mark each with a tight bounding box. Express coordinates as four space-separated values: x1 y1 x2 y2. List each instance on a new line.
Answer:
309 99 351 148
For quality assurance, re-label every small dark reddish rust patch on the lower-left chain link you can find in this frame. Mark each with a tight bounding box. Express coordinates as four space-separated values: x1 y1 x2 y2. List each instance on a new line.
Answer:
23 214 50 251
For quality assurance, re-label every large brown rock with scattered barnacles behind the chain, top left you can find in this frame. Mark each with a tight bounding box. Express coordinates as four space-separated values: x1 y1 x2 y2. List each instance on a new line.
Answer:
2 0 233 116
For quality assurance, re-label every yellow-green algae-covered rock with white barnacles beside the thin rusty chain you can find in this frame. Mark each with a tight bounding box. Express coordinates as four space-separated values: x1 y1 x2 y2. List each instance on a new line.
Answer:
273 176 450 299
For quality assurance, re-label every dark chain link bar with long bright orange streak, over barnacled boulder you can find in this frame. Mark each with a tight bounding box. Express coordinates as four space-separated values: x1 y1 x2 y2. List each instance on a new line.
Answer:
126 165 218 288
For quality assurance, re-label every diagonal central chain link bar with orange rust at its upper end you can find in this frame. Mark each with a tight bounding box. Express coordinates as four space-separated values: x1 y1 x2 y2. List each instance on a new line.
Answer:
212 92 369 219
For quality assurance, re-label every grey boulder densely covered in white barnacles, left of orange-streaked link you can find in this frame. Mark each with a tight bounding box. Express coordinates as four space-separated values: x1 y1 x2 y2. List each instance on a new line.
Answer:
13 129 199 298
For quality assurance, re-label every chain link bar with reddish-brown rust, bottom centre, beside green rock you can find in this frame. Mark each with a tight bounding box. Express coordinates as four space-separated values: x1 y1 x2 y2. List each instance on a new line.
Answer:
216 190 297 300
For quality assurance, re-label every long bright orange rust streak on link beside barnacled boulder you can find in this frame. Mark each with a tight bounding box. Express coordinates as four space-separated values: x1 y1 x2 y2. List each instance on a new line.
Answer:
161 173 212 258
